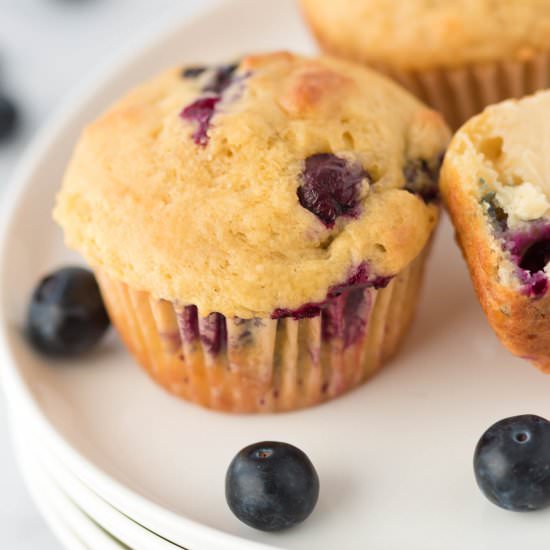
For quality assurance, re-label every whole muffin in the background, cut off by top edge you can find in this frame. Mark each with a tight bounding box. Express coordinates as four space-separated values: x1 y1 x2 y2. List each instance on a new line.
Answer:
300 0 550 128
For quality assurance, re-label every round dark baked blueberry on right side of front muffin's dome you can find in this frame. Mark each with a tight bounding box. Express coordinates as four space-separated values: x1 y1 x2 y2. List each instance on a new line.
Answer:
297 153 369 228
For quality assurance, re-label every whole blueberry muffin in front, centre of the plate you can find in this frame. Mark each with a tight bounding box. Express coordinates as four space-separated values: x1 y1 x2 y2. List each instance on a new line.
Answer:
54 52 449 412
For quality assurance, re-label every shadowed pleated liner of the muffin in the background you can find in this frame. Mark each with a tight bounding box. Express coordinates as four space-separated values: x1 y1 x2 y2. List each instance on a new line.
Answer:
380 52 550 130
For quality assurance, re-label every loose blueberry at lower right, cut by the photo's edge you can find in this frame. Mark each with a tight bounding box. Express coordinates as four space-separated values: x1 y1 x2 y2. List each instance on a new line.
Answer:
474 414 550 511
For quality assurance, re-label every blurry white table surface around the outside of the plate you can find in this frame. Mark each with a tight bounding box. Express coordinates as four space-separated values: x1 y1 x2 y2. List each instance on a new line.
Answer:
0 0 204 550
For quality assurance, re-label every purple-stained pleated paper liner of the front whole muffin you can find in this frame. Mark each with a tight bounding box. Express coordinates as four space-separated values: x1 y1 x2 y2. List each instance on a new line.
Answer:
96 247 428 413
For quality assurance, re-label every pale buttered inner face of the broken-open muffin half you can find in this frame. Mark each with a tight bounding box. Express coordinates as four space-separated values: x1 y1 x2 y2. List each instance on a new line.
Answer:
441 91 550 297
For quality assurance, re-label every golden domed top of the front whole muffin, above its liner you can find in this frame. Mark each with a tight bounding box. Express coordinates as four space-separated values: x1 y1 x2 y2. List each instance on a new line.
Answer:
54 52 448 318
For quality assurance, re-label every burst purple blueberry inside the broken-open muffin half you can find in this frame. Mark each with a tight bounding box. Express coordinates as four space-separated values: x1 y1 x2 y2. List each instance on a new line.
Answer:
503 221 550 298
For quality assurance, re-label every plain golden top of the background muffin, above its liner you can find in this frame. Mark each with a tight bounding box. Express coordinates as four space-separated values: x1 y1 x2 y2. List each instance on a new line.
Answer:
300 0 550 70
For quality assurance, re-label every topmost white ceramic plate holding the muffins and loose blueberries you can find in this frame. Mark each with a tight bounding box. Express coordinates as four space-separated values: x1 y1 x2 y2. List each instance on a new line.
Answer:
0 0 550 550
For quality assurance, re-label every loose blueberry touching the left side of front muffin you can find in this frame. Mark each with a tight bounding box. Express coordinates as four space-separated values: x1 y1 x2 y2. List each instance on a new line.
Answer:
26 267 109 356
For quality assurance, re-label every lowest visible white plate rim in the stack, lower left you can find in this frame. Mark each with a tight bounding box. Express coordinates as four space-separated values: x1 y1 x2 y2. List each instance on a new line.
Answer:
12 422 123 550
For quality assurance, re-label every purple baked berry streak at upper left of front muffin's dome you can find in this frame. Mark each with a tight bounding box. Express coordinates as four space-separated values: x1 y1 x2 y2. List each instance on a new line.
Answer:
180 64 243 147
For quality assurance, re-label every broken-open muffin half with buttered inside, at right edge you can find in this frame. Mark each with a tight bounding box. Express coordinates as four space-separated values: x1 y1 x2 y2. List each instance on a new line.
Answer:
441 92 550 372
